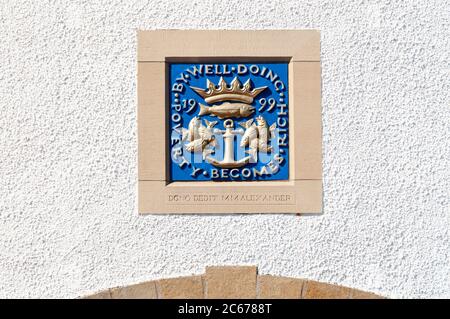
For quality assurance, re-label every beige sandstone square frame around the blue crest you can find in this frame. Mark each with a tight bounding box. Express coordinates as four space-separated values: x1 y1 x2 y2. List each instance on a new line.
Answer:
137 30 322 214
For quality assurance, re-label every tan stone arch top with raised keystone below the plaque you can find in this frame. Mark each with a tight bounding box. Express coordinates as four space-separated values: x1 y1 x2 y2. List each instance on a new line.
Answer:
84 266 383 299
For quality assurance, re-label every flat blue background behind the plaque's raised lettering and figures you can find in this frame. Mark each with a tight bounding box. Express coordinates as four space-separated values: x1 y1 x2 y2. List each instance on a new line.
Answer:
168 63 289 181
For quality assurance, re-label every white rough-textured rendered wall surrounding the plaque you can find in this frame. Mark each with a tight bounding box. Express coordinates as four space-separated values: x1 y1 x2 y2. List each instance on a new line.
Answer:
0 0 450 298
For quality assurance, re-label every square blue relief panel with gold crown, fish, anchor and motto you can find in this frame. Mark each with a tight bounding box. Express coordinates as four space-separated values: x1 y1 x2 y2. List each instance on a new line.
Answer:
169 63 288 181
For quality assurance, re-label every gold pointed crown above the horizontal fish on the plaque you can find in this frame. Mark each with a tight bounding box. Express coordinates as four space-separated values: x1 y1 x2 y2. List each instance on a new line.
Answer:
191 77 267 104
